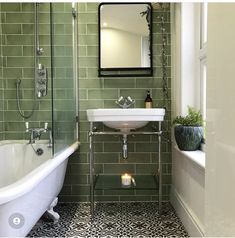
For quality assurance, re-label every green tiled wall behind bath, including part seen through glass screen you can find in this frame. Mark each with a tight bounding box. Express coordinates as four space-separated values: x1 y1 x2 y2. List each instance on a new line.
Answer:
0 3 76 152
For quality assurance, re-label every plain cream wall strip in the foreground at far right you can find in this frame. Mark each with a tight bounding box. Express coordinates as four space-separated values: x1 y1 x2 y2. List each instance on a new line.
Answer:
206 3 235 237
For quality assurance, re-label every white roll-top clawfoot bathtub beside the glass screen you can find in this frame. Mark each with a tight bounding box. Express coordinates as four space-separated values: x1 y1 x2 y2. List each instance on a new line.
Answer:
0 141 79 237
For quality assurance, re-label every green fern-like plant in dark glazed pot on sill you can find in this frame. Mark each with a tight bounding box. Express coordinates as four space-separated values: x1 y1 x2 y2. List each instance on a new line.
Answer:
173 107 203 151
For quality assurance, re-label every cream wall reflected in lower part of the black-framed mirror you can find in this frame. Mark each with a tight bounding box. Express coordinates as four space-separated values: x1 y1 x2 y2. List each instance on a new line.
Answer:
101 28 141 68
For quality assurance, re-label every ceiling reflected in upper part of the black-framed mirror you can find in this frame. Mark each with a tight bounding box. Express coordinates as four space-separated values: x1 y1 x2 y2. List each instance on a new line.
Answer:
100 4 149 36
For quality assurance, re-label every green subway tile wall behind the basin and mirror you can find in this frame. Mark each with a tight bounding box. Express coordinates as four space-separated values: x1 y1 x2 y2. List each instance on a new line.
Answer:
60 3 171 202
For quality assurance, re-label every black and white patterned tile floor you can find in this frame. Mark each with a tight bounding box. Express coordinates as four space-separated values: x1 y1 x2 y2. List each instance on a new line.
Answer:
28 202 189 237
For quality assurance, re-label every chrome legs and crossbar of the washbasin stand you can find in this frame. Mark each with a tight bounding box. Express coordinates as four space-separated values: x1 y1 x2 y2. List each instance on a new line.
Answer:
88 121 162 219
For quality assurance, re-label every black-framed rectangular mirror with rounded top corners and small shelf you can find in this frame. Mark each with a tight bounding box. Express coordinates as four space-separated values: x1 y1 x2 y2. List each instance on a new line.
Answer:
98 3 153 77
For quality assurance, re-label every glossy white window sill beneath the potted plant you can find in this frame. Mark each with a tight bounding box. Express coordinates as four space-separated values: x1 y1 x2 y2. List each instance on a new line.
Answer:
175 145 206 169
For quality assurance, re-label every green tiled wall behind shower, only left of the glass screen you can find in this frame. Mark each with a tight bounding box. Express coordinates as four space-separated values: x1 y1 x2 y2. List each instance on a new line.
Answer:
0 3 52 139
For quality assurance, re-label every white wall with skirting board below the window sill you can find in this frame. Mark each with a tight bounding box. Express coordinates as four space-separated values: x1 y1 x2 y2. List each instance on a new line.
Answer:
171 148 205 237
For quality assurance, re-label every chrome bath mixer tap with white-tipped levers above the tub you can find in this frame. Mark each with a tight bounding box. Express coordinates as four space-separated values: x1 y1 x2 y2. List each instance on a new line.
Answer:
25 122 52 147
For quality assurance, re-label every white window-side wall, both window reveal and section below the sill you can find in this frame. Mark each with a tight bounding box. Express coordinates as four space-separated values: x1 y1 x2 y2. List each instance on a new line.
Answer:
171 3 205 237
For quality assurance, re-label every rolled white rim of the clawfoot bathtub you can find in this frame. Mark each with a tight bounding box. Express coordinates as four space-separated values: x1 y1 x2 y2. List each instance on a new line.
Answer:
0 140 80 205
